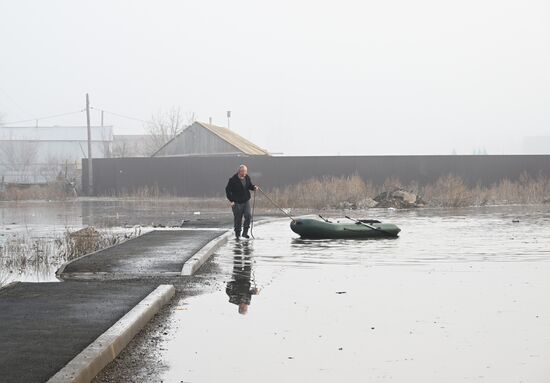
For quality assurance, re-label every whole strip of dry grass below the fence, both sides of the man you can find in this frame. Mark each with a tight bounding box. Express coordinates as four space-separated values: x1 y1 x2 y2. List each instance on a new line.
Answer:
5 174 550 211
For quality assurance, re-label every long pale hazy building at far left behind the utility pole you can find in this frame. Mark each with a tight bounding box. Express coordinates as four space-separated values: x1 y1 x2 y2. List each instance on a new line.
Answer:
0 126 113 183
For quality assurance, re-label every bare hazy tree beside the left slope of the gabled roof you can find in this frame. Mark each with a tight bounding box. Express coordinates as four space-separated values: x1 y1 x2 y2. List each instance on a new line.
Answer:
145 106 195 155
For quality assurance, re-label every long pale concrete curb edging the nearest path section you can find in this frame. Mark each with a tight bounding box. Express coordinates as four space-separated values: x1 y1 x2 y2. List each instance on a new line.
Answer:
47 285 175 383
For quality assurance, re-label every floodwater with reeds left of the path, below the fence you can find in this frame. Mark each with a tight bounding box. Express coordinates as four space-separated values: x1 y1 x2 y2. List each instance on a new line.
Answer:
0 199 219 286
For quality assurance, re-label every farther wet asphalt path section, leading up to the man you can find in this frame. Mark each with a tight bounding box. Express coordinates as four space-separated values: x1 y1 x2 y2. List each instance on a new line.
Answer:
58 230 225 279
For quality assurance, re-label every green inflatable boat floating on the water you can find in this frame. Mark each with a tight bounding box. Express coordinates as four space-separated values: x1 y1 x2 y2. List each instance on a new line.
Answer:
290 215 401 239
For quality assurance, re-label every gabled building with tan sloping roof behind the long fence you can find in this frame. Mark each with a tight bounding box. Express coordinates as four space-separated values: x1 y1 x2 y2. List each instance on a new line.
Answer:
152 121 269 157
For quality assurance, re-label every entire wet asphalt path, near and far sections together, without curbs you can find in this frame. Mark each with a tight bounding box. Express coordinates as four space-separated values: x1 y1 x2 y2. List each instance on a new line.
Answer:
0 215 242 383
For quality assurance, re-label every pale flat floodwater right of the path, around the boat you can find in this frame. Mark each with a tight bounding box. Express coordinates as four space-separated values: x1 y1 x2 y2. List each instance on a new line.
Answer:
161 207 550 382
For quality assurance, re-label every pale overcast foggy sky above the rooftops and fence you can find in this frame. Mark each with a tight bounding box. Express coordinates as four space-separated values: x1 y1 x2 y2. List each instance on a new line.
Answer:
0 0 550 155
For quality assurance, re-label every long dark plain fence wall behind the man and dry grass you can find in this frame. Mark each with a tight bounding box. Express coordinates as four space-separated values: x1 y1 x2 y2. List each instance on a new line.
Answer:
82 155 550 197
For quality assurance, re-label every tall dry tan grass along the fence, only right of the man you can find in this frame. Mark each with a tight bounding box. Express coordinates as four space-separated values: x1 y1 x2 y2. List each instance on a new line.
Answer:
259 174 550 209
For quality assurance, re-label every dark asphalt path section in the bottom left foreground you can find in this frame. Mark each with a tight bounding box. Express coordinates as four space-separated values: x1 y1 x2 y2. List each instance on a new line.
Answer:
0 281 157 383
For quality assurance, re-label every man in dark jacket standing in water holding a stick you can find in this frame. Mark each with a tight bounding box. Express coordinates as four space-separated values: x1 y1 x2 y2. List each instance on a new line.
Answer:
225 165 258 239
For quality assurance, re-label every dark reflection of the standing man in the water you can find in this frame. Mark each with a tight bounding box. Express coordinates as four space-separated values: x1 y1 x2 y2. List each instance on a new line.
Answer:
225 242 260 315
